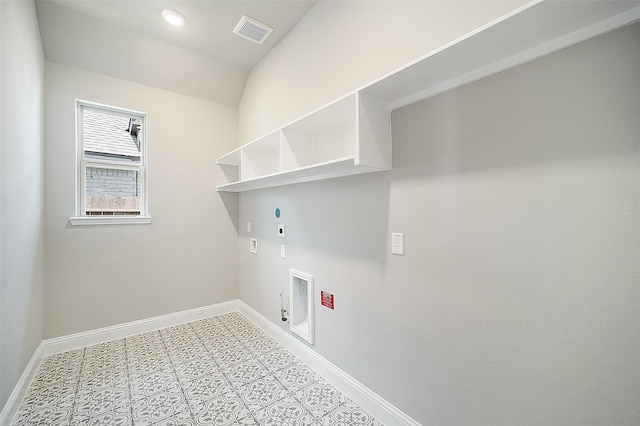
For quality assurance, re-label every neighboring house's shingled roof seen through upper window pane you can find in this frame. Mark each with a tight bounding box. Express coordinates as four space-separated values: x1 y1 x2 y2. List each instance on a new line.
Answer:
82 108 140 160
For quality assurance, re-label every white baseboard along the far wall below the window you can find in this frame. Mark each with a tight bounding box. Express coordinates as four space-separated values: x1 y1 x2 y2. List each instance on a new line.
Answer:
42 300 238 356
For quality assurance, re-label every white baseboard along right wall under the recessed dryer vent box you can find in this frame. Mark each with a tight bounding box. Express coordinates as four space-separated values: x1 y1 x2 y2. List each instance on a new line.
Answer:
239 301 420 426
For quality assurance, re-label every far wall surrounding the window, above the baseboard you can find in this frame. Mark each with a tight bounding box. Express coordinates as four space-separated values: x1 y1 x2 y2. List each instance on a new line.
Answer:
44 62 238 338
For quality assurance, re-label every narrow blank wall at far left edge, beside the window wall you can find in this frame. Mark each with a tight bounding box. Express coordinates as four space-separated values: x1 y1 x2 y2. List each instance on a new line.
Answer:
0 1 44 411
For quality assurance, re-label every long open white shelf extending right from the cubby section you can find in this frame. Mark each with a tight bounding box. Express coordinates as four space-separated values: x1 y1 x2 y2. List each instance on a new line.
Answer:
360 0 640 110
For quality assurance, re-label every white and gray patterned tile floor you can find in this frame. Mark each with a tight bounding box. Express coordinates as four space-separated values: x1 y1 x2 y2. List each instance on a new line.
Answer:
12 312 381 426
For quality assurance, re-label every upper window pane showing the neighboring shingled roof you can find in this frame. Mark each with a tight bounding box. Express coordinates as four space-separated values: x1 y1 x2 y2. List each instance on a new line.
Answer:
82 107 142 164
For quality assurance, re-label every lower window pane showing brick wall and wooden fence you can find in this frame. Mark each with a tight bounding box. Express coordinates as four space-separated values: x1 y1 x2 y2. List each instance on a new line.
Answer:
85 167 140 216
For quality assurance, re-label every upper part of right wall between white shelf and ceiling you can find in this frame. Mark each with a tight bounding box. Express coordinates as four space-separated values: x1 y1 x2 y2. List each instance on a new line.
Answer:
238 0 529 144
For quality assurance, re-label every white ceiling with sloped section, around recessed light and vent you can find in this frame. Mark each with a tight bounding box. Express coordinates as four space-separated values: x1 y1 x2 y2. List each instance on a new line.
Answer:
36 0 317 107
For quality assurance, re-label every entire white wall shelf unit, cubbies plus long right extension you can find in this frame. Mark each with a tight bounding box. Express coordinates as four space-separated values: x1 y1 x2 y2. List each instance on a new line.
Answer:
217 0 640 192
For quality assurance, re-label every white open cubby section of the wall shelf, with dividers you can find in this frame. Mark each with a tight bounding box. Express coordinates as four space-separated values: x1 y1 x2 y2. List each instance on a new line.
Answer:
217 92 391 192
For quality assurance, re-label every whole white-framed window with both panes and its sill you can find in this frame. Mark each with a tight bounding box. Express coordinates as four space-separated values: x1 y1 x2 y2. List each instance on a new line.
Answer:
71 101 150 225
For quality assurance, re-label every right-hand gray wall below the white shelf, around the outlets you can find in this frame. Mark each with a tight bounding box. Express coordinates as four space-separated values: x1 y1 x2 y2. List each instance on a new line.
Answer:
239 24 640 425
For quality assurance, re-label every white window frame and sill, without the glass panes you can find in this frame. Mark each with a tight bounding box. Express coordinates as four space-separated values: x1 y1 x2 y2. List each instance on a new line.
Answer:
69 99 151 226
